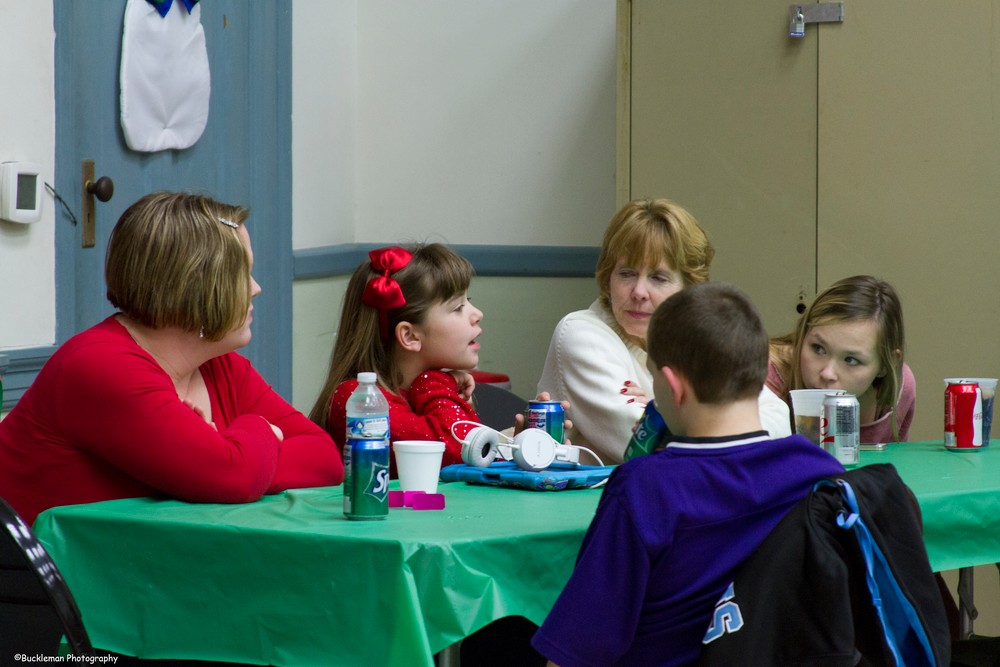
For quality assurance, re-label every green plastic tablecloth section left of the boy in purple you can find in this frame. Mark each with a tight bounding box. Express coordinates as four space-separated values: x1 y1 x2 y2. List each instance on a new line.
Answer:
34 483 601 666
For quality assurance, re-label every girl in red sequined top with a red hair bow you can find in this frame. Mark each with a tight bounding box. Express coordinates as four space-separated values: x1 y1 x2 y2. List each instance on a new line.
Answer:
309 243 483 477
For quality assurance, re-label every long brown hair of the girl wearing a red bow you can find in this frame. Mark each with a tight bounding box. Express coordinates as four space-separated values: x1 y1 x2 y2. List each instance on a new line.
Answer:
309 243 474 435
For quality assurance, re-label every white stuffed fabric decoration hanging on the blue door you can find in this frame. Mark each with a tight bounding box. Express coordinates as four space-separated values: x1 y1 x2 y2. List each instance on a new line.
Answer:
121 0 212 152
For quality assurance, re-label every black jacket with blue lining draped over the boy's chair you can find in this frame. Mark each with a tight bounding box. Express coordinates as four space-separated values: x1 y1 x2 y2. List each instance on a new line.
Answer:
699 464 951 666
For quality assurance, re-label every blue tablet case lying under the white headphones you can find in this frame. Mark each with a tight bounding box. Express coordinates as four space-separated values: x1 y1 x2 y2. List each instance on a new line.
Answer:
441 461 615 491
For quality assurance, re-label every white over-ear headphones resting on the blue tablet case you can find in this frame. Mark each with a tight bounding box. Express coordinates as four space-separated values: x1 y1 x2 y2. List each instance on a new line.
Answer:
451 421 589 472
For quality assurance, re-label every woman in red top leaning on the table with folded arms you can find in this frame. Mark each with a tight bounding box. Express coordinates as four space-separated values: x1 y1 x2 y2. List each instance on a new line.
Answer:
0 192 344 522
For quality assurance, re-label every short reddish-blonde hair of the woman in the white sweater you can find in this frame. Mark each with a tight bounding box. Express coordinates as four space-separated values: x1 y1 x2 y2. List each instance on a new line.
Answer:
595 199 715 308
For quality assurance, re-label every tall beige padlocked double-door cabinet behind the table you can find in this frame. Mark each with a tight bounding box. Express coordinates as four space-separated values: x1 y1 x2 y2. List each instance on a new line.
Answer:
621 0 1000 440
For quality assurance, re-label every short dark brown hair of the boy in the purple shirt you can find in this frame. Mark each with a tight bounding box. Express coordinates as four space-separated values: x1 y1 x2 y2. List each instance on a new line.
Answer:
646 282 768 404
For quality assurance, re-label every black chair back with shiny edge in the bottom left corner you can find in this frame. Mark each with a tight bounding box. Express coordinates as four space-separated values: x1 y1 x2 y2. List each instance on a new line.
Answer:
0 498 96 656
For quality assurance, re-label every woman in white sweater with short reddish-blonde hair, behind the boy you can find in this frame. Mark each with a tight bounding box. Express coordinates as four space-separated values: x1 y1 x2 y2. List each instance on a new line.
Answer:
538 199 790 465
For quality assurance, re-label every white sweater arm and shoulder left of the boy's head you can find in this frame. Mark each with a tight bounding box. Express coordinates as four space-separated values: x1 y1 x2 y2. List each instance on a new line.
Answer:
538 311 653 465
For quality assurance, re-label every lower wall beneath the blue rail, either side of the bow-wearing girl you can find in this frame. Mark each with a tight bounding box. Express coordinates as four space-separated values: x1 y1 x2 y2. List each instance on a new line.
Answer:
292 277 597 413
